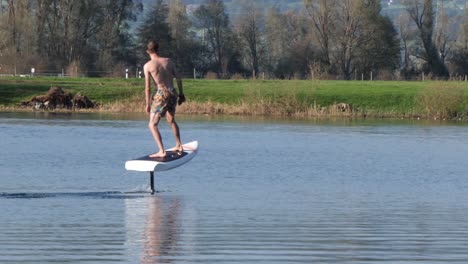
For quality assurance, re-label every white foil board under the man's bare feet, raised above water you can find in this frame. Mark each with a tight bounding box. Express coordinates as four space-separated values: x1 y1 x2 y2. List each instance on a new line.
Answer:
125 141 198 172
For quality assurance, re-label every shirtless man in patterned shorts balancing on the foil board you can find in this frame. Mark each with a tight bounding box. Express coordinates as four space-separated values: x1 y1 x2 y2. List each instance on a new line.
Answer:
143 41 185 158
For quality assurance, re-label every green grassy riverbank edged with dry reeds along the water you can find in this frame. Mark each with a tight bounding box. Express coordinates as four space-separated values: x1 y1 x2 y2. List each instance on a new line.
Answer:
0 78 468 119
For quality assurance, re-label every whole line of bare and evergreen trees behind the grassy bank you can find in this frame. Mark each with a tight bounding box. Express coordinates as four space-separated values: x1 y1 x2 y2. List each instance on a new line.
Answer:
0 0 468 79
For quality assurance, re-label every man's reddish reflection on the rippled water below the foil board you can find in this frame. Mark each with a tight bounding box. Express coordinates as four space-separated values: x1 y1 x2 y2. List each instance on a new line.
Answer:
141 196 180 263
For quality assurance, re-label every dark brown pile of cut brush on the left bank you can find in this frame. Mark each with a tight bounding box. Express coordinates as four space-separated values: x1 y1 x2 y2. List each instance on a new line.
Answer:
21 87 97 110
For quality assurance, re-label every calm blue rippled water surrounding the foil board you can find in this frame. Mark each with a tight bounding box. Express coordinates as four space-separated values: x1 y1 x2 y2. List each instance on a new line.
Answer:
0 113 468 263
